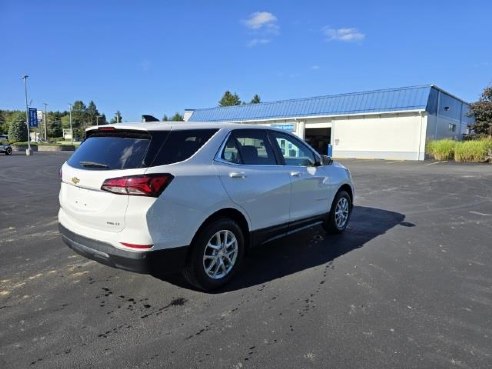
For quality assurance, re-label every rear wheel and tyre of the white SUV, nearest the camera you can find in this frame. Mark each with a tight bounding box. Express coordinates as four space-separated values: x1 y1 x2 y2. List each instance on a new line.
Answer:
183 218 244 291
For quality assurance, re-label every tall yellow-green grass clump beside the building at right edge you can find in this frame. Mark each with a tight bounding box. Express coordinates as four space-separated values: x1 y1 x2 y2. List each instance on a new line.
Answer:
427 138 492 163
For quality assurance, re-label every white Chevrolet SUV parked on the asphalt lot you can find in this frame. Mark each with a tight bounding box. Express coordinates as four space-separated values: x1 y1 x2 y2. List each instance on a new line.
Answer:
58 123 354 290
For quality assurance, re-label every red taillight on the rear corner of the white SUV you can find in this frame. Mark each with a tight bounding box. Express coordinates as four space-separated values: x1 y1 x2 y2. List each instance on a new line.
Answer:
101 174 174 197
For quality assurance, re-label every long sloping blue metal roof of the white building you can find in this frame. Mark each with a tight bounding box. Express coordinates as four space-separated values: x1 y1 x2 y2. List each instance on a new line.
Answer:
189 85 436 122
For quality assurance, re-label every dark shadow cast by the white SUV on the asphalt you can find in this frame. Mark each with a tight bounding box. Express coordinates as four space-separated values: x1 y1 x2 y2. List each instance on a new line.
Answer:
155 206 413 294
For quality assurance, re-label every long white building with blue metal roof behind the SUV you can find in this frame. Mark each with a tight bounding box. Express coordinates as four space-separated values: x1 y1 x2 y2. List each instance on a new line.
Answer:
184 85 473 160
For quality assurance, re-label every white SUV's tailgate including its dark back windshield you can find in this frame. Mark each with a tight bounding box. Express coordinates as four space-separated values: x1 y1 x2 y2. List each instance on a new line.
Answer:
59 128 165 232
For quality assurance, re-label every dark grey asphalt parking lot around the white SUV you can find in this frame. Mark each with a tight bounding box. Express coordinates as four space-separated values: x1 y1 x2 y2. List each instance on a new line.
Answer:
0 153 492 369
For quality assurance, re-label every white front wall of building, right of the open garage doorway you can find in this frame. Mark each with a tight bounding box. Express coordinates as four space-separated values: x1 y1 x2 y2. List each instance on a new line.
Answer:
332 113 427 160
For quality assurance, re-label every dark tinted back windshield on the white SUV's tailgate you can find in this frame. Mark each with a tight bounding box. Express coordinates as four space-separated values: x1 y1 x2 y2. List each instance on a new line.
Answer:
68 130 152 170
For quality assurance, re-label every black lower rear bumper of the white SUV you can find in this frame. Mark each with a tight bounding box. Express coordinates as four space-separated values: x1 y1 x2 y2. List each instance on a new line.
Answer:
58 224 189 274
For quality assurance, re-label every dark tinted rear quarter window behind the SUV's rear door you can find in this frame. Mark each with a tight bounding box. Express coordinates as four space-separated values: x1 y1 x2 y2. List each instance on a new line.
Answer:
152 129 218 166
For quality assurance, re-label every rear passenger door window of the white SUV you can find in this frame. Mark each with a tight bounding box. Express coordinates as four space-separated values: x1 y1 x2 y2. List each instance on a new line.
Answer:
221 129 277 165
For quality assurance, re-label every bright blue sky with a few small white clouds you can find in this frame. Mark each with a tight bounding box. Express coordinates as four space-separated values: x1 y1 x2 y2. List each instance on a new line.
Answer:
0 0 492 121
